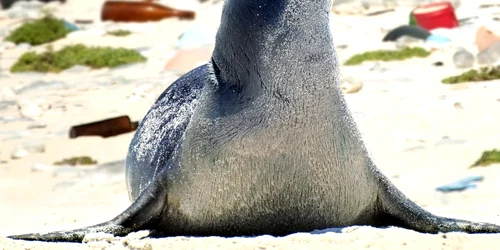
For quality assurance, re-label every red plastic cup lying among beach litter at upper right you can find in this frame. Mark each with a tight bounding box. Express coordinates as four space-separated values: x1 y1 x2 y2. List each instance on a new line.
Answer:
412 2 459 30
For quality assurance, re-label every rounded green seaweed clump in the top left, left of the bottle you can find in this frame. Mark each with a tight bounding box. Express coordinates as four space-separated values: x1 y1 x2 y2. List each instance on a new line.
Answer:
5 15 71 45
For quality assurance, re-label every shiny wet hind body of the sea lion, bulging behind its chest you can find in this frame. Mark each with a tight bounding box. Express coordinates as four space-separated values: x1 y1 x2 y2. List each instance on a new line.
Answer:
125 64 210 201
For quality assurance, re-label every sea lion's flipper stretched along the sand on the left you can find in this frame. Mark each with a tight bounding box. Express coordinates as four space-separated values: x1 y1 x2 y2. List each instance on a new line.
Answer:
7 168 167 242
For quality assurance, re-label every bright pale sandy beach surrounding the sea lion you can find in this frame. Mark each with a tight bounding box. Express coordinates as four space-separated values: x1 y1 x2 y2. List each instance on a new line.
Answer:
0 0 500 249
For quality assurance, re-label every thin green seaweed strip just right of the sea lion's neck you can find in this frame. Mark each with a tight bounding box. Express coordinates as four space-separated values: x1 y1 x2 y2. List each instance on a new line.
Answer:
344 47 431 65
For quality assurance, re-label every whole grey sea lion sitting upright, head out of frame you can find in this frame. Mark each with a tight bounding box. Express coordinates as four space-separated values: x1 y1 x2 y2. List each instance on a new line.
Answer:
6 0 500 241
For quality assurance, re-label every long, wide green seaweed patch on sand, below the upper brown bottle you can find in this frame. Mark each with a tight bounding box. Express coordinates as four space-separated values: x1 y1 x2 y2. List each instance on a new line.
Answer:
10 44 146 73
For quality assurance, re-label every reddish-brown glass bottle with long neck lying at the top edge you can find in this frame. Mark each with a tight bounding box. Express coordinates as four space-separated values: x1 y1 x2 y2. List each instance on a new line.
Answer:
101 1 195 22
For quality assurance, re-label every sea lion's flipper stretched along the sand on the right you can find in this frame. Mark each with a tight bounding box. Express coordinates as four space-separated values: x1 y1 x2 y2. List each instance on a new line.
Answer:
374 175 500 233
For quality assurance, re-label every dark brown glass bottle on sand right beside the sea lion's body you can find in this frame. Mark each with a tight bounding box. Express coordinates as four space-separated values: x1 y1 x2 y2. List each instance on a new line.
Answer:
69 116 139 138
